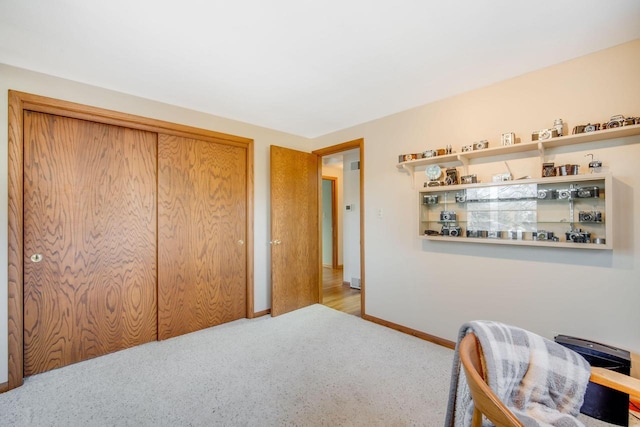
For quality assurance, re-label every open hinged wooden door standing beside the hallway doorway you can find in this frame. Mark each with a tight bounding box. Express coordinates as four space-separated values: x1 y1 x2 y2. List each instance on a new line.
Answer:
271 145 320 316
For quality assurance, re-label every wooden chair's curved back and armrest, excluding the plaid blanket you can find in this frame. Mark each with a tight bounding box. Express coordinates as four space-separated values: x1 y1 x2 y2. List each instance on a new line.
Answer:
459 333 640 427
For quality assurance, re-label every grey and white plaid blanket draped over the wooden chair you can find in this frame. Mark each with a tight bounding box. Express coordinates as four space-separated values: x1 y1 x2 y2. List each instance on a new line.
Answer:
445 321 590 427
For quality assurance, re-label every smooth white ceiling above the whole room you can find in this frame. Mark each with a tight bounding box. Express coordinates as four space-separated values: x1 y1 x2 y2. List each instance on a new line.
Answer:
0 0 640 137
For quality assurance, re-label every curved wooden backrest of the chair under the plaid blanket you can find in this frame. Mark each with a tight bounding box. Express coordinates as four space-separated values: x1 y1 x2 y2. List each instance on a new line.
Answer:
459 333 524 427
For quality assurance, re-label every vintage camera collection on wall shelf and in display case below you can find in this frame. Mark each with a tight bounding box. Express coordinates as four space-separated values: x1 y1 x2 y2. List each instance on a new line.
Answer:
398 115 640 249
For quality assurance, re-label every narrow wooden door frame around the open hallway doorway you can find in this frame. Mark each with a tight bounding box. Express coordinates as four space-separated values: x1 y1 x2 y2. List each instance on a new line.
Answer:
312 138 366 318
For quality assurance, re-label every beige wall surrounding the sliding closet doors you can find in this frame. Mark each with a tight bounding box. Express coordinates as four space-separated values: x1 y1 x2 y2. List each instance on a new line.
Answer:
0 64 310 384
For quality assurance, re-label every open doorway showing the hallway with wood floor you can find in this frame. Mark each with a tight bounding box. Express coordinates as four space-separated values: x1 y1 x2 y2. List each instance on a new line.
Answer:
318 144 364 316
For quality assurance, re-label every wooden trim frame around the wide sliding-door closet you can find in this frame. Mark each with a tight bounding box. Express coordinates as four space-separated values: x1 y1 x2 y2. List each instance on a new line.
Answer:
6 90 255 392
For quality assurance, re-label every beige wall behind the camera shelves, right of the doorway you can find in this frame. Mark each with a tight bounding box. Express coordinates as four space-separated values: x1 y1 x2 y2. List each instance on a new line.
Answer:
313 40 640 352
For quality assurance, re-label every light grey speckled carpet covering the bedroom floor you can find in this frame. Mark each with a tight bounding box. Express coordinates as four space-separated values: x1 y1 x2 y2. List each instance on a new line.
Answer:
0 305 453 426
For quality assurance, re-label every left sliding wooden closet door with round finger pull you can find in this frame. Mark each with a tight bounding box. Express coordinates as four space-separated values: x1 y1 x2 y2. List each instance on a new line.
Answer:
23 111 157 375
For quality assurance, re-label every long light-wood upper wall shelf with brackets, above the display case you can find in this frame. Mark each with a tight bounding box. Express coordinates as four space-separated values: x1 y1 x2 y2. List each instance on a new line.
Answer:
397 122 640 181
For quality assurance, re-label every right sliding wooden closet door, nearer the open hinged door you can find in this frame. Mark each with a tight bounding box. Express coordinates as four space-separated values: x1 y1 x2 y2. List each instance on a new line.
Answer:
158 134 247 339
